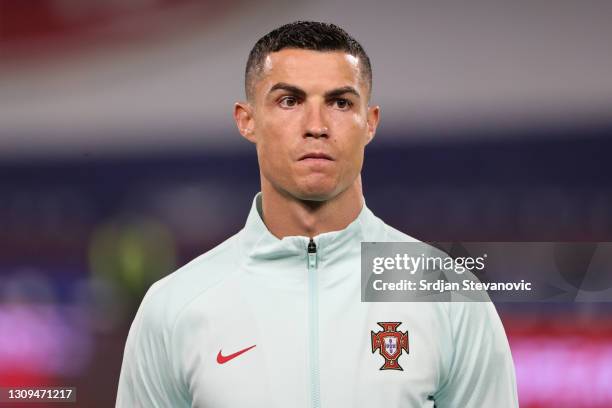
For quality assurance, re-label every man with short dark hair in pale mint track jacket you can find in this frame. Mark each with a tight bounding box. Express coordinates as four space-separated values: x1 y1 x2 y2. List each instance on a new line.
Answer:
117 22 518 408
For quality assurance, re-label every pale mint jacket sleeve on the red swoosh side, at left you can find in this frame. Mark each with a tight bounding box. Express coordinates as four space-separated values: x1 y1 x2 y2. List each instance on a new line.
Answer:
115 284 190 408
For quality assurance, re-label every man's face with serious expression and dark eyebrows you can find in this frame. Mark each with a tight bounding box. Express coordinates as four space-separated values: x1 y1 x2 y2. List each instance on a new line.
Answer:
239 49 378 201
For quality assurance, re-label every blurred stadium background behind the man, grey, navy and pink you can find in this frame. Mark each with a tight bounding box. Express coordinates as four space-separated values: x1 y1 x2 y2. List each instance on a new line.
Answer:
0 0 612 408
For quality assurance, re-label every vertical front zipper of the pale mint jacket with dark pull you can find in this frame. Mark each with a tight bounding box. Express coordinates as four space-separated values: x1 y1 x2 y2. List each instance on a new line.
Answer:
308 238 321 408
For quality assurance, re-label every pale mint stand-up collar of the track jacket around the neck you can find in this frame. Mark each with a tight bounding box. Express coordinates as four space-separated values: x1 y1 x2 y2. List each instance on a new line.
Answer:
242 192 382 261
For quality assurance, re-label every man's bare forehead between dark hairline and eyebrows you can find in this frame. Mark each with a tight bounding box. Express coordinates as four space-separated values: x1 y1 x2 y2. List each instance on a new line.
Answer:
257 49 365 90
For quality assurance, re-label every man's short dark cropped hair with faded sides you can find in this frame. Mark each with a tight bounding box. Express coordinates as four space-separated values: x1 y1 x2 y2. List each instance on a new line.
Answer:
244 21 372 100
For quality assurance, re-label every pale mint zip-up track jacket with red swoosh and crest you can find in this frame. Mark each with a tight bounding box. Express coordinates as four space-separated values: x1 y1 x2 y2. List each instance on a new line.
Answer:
116 194 518 408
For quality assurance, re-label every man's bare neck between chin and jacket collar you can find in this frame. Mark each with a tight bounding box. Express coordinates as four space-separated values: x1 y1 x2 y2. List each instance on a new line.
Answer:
261 176 363 239
